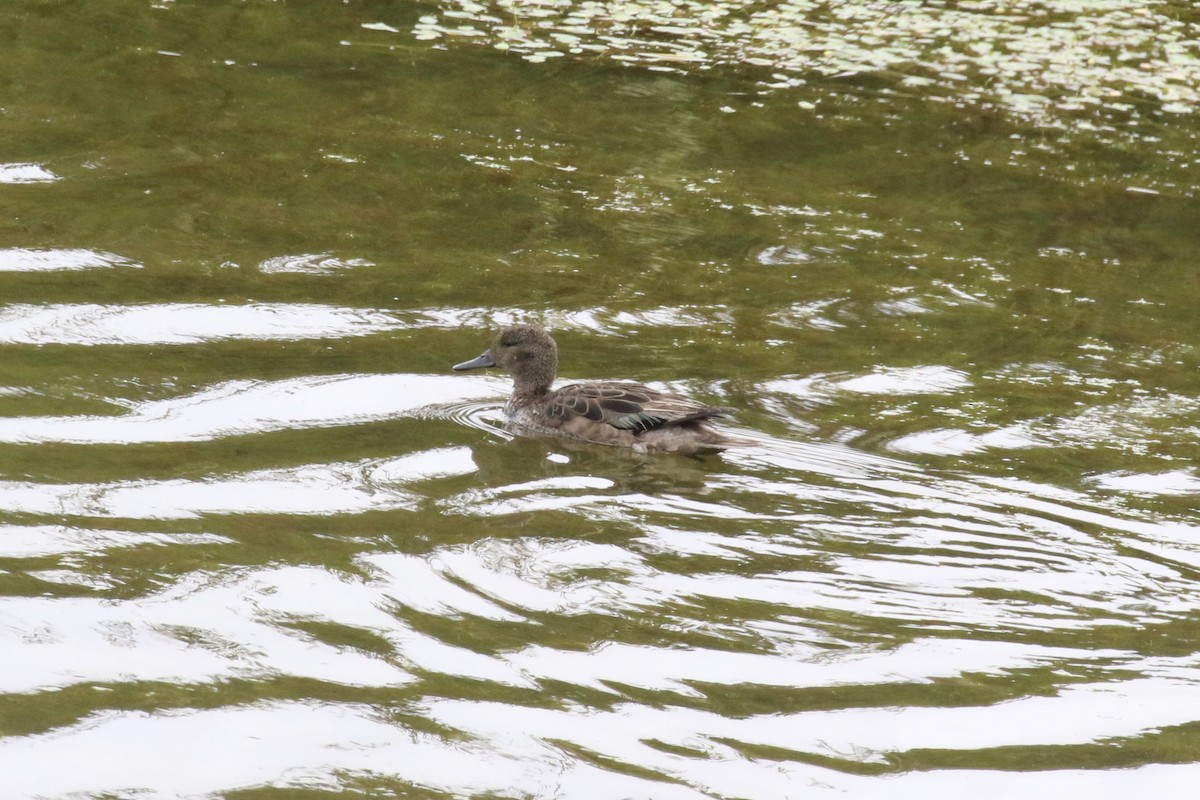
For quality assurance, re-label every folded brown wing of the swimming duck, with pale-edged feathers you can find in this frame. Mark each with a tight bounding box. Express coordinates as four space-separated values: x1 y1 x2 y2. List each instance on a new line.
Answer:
547 384 733 434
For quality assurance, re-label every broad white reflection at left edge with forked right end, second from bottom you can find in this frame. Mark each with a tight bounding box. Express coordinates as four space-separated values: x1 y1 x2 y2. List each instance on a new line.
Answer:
0 567 410 695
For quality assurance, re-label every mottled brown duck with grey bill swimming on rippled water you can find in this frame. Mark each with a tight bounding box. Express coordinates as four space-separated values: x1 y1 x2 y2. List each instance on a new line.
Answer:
454 324 751 455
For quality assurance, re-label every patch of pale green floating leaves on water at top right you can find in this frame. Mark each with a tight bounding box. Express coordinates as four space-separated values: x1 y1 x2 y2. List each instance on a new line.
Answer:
412 0 1200 133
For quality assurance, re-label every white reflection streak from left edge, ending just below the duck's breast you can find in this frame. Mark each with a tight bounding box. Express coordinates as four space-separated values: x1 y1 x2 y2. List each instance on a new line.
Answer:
0 447 475 519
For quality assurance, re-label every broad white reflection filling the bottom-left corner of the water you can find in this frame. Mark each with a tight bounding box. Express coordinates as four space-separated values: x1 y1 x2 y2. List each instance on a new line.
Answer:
0 703 709 800
